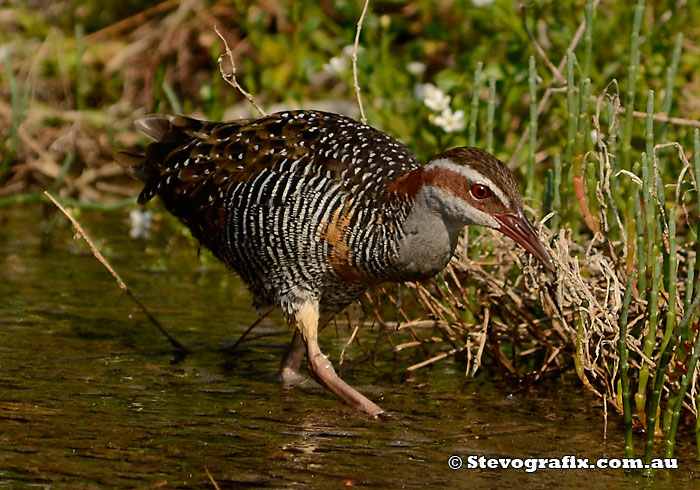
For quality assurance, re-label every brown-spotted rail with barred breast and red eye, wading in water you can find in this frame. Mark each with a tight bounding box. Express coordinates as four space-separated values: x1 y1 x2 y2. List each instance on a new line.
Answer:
118 110 554 417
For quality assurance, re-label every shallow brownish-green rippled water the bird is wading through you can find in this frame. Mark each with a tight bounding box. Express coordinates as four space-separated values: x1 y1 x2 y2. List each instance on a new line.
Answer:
0 207 700 488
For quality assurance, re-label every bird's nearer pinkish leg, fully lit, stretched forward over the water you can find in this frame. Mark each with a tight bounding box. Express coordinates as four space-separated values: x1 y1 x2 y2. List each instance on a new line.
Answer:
296 300 384 417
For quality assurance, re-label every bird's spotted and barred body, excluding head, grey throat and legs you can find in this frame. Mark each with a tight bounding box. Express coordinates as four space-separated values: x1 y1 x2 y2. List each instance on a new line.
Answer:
122 111 420 315
